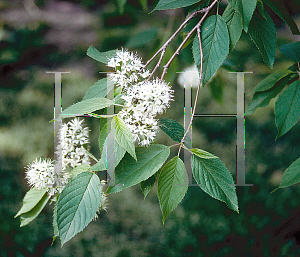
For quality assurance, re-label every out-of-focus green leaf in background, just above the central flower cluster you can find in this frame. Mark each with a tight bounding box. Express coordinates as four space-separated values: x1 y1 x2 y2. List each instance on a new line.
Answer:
126 28 158 48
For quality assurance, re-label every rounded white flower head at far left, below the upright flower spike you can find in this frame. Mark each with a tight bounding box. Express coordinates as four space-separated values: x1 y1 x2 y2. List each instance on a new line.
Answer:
26 158 70 196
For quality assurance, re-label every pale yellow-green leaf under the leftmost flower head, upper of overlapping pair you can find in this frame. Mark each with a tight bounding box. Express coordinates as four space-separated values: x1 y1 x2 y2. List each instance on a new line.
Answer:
15 187 48 218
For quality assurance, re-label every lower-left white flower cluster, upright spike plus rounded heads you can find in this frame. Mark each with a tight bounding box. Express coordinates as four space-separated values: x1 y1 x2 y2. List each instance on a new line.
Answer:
26 118 90 196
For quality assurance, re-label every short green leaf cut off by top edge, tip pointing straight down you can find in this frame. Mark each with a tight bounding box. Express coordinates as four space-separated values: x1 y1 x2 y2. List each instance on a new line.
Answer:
228 0 257 32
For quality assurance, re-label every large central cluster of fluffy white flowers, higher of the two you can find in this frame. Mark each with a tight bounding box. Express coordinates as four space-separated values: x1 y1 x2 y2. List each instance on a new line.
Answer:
108 49 173 146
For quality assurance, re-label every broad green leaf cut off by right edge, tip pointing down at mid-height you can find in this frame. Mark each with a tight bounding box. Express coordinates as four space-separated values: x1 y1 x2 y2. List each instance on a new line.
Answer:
275 80 300 139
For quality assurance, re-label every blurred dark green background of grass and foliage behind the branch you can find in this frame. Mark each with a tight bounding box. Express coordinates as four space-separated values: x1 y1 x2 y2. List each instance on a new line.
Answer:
0 0 300 257
